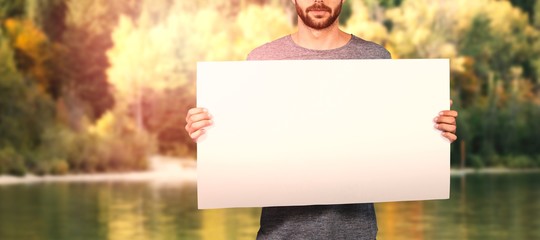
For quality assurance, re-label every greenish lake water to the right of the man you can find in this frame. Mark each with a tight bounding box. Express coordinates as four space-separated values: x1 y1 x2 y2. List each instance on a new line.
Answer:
377 174 540 240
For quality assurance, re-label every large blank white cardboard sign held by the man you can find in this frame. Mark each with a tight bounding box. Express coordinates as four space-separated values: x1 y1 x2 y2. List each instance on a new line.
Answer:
197 59 450 209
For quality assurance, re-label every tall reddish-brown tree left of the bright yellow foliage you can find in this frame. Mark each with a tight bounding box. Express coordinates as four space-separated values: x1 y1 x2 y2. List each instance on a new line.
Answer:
56 0 138 125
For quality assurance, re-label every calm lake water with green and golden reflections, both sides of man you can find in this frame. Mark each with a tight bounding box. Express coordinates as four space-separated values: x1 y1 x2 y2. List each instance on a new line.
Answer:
0 173 540 240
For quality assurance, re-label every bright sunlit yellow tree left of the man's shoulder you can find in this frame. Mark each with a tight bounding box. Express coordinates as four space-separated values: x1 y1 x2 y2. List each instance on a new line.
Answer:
107 1 292 154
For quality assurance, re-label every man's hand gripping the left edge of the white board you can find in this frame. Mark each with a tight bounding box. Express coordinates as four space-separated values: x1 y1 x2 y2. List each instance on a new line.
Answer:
186 108 213 142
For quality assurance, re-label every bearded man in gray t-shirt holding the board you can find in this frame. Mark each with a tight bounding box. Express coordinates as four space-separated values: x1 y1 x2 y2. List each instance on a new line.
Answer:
186 0 457 239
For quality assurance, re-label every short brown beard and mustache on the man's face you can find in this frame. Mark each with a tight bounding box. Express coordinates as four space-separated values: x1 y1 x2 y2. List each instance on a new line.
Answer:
294 1 343 30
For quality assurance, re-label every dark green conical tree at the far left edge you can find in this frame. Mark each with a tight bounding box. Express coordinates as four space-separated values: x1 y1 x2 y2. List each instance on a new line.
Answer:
0 32 54 174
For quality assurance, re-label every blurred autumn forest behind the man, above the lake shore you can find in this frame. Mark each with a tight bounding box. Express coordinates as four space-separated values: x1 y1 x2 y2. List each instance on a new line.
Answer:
0 0 540 175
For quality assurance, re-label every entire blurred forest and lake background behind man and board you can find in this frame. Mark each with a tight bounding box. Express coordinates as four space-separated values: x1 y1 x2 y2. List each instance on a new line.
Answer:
0 0 540 240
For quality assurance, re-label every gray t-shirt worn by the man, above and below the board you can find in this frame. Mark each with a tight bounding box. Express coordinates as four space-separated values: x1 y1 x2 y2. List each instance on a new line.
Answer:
248 35 391 240
